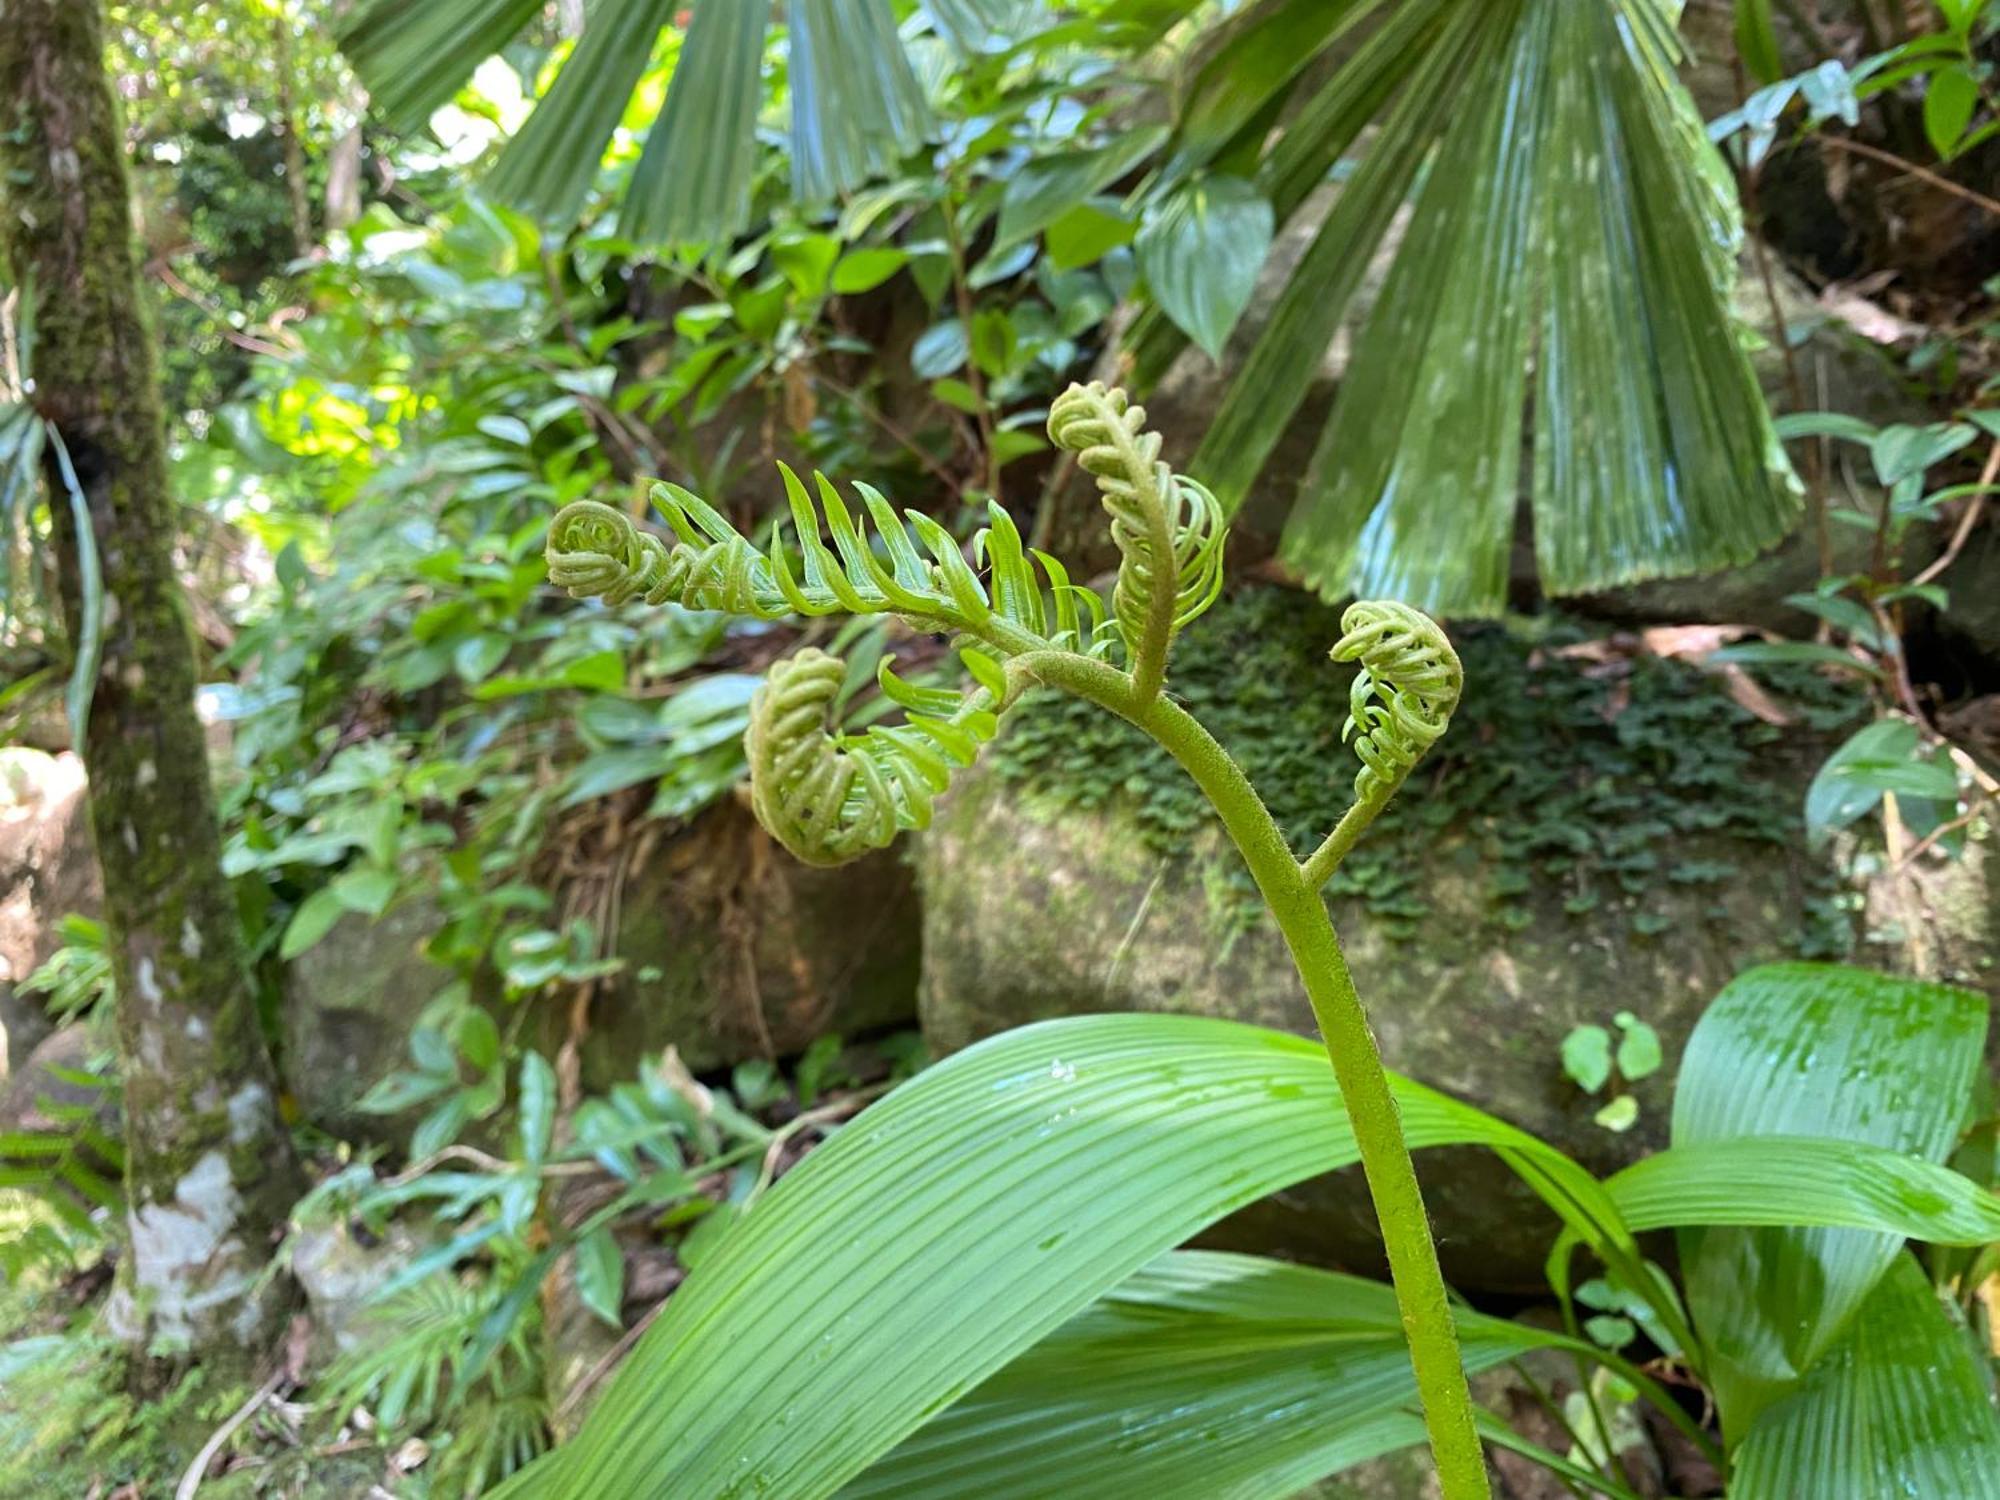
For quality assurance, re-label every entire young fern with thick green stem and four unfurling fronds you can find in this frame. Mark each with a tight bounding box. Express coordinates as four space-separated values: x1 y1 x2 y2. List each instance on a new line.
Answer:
548 384 1488 1500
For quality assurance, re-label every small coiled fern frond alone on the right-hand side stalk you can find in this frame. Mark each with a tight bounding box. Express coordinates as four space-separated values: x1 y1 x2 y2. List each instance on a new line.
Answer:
1332 600 1466 802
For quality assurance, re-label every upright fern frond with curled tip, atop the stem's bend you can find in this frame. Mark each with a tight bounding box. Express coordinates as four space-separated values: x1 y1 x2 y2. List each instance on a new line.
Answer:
1048 380 1228 688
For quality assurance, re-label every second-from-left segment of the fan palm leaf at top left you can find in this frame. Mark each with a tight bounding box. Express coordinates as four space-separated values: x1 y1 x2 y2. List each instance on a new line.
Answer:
488 0 674 228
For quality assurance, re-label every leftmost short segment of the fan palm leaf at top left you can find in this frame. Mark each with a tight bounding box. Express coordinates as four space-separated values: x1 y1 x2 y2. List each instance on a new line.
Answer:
336 0 542 130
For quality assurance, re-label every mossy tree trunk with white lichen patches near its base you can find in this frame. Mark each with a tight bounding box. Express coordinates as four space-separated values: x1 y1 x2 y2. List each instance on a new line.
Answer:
0 0 298 1386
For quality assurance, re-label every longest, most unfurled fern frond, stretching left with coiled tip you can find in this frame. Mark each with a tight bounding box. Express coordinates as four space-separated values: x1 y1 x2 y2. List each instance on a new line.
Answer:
548 464 1104 656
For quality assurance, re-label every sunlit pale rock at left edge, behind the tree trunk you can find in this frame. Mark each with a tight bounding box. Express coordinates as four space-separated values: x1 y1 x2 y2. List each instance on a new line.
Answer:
0 748 104 1078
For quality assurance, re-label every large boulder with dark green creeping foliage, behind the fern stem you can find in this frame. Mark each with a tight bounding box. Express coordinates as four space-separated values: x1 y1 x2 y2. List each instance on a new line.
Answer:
918 590 1994 1290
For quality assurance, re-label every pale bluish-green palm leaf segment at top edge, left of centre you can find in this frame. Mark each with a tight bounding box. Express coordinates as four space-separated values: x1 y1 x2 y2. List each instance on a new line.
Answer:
788 0 930 202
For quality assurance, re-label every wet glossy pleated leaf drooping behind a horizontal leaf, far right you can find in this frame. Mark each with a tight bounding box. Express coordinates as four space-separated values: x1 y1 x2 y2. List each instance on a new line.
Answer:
1672 964 1992 1438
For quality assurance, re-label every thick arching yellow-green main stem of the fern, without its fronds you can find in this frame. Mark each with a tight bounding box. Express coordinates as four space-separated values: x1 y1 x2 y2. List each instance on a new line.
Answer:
1008 652 1490 1500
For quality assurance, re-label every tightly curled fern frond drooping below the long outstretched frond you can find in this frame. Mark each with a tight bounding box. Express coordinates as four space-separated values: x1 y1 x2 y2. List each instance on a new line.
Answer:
744 646 1006 866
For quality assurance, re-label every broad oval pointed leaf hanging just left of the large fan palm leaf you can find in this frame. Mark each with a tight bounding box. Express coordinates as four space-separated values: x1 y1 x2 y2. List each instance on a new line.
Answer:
1134 176 1272 360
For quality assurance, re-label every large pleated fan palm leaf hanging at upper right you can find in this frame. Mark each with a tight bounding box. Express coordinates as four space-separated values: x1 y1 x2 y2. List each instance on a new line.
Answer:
1184 0 1798 612
